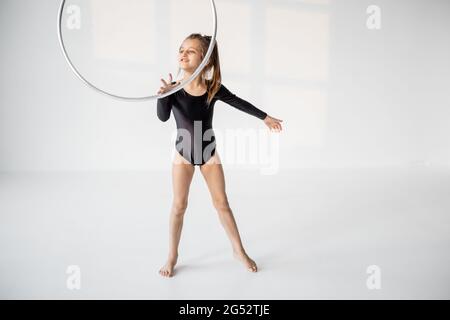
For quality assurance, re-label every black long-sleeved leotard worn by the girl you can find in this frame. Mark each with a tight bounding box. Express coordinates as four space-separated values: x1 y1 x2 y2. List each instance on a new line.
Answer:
157 84 267 165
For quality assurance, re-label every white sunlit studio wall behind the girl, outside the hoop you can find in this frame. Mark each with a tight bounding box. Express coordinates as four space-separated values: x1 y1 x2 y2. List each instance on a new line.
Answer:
0 0 450 171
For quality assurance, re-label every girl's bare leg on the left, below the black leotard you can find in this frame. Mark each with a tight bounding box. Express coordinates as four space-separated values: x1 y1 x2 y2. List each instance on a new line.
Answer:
159 152 195 277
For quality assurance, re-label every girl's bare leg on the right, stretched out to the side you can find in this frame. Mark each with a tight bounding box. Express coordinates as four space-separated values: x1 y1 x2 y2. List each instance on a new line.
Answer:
200 150 257 272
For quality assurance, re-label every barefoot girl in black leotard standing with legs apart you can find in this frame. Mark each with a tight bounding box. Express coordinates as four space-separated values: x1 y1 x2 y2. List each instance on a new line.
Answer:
157 33 282 277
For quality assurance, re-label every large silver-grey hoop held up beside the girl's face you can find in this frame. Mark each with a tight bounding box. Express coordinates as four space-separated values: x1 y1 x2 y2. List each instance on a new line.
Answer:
57 0 217 101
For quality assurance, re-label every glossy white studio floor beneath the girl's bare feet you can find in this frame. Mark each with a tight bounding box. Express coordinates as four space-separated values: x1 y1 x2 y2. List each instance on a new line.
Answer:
0 167 450 299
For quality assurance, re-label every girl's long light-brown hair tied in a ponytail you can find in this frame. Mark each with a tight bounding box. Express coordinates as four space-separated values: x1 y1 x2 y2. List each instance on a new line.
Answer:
178 33 222 105
